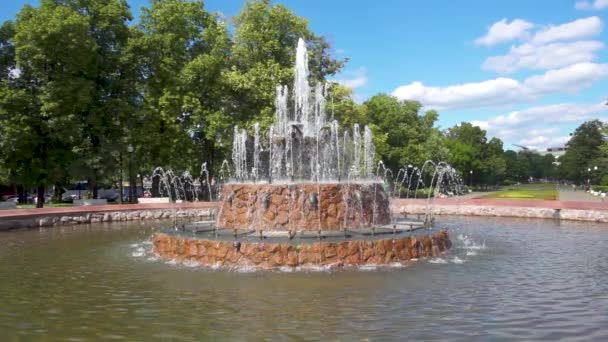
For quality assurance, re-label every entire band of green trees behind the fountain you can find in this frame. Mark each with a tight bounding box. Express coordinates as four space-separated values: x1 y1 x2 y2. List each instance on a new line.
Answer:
0 0 608 206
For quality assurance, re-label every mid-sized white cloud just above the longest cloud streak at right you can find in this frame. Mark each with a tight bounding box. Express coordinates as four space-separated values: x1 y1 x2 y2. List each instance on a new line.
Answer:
482 40 604 74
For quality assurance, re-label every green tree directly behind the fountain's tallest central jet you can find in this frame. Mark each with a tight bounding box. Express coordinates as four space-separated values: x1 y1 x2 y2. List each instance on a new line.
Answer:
224 0 344 135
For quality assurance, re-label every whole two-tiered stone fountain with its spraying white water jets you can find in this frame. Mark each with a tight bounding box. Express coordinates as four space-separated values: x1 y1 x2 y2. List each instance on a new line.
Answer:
154 39 450 268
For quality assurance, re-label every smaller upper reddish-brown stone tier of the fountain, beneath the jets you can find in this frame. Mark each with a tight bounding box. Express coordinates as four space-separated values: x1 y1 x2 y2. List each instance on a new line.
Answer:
217 182 390 231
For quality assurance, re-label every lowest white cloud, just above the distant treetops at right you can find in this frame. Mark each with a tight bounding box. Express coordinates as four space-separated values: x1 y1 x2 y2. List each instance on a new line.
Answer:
472 103 608 150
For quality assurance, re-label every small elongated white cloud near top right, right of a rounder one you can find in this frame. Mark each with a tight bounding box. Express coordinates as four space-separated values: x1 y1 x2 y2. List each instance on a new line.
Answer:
531 17 603 45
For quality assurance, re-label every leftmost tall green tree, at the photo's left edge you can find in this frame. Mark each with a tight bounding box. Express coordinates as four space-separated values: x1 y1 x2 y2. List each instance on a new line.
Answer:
0 0 95 207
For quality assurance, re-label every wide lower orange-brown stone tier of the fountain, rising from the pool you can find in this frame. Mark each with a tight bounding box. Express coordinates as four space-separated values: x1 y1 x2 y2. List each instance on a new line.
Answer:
153 230 451 269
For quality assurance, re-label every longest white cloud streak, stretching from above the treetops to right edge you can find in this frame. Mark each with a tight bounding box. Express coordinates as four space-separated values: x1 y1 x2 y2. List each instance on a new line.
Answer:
392 63 608 110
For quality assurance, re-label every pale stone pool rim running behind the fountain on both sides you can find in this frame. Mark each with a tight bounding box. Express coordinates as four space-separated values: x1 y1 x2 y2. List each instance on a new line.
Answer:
0 199 608 231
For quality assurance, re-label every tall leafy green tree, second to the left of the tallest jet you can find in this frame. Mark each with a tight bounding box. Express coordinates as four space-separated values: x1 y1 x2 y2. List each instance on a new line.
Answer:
132 0 231 173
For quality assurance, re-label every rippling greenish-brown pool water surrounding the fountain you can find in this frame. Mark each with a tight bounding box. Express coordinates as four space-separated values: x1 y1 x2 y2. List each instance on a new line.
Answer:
0 218 608 341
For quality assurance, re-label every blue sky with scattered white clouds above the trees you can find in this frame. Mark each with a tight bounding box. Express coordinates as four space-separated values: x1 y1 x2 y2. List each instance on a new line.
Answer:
0 0 608 149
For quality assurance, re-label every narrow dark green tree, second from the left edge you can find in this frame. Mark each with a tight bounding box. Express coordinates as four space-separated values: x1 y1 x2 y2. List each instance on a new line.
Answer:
50 0 137 197
